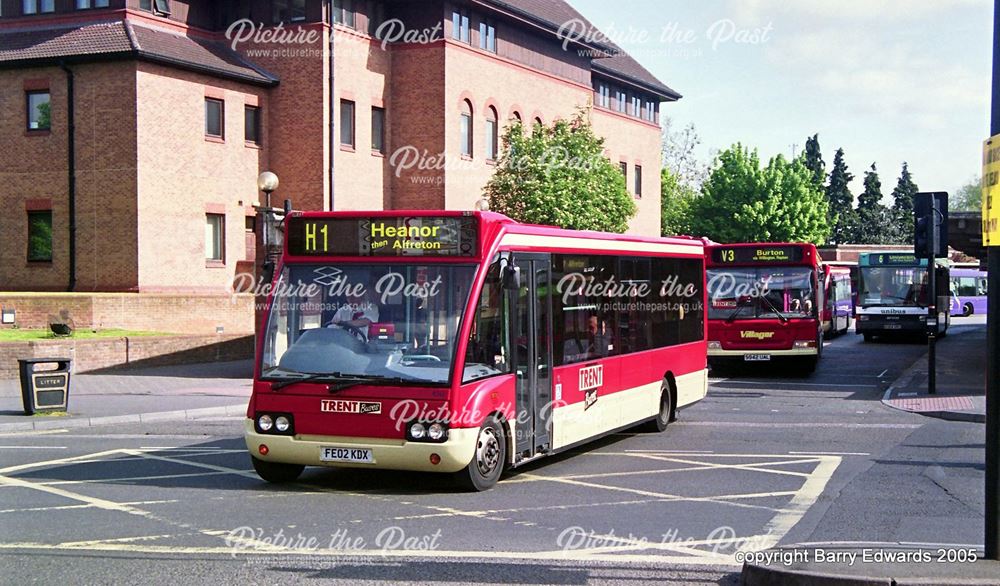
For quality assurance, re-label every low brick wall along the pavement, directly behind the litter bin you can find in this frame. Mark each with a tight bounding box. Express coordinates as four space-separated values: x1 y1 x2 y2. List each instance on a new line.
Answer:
0 335 254 378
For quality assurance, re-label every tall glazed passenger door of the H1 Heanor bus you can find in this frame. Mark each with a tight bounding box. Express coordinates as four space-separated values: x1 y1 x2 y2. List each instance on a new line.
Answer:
510 253 552 463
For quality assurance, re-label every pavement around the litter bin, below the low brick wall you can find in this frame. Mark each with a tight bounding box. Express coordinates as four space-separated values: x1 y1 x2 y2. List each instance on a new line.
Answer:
0 360 253 432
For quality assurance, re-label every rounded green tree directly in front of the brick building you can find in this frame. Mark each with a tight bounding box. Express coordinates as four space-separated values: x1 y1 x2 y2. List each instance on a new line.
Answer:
485 113 637 233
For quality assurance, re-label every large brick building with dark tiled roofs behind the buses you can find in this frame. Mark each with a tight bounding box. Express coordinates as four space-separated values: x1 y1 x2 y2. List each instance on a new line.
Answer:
0 0 680 295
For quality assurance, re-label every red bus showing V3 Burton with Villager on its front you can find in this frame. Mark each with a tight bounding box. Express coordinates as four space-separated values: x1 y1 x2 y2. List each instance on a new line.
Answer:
706 243 825 370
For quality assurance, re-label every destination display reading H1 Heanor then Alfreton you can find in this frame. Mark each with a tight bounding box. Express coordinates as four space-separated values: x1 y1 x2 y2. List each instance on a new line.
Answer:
286 216 477 256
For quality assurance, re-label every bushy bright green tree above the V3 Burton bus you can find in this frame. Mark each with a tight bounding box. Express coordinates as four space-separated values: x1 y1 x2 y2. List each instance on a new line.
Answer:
692 144 829 244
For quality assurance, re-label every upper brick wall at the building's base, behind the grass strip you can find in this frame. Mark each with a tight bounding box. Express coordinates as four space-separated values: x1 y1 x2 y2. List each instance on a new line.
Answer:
0 293 254 334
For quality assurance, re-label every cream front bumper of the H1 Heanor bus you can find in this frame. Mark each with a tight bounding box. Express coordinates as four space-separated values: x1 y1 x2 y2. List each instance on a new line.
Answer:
243 419 479 472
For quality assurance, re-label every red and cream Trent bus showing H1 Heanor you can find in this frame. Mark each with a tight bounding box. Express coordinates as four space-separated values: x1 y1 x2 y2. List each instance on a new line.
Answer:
245 212 708 490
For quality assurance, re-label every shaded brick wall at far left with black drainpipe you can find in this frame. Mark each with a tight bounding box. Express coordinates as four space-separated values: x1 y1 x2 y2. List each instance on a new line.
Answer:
0 62 137 291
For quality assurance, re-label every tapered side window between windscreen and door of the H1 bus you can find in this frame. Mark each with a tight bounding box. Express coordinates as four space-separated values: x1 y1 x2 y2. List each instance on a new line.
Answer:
465 263 510 374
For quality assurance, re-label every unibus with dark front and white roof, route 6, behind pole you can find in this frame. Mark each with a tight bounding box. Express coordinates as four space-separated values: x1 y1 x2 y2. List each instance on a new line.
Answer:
855 252 951 342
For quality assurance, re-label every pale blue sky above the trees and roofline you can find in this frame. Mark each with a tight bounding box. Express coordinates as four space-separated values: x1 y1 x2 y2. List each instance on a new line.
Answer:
570 0 993 196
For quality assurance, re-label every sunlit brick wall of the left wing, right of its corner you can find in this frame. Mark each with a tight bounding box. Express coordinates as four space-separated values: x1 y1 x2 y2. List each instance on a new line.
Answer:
136 63 269 295
